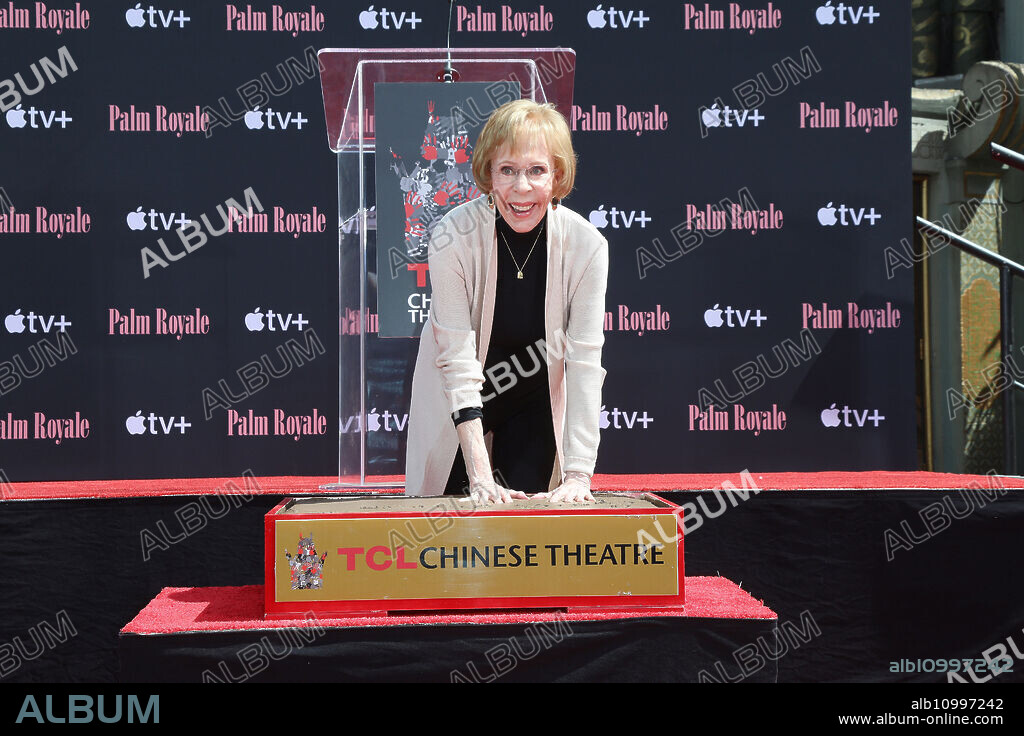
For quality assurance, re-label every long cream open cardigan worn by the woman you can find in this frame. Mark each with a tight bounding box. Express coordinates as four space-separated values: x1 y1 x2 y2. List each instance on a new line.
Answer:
406 197 608 495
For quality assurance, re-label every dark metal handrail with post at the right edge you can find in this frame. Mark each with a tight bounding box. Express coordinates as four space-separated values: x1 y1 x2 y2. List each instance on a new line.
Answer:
916 143 1024 475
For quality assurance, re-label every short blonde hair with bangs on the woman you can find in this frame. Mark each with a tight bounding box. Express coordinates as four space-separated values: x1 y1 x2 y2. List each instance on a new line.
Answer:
473 99 575 200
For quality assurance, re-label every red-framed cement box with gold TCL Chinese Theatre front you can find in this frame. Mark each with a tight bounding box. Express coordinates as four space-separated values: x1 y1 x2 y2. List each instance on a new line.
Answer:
264 493 684 618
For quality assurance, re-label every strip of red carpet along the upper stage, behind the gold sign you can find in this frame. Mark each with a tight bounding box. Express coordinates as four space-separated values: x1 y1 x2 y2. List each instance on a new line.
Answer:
0 471 1024 501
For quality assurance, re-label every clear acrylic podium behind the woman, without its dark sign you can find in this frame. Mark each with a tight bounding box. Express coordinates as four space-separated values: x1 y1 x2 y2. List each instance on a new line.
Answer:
318 48 575 492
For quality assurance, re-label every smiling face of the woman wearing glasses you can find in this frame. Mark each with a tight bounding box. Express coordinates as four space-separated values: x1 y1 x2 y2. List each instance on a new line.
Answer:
490 136 556 232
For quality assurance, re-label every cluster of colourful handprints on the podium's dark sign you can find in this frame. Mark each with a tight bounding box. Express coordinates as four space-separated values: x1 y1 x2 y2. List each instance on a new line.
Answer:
389 100 481 258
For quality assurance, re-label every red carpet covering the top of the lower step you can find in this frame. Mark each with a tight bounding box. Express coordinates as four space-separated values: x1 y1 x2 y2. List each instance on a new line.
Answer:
121 577 776 635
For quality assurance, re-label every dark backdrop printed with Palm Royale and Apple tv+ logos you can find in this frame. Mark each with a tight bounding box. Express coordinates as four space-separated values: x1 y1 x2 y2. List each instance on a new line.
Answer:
0 0 916 482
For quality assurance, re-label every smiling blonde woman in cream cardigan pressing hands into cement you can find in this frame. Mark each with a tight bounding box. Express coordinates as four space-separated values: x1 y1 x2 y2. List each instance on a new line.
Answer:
406 100 608 504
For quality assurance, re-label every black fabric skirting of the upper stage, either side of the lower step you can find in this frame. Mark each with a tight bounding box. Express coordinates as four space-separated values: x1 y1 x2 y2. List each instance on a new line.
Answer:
0 490 1024 683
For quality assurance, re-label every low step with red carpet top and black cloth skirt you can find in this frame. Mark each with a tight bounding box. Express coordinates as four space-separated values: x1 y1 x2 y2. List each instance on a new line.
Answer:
118 577 778 688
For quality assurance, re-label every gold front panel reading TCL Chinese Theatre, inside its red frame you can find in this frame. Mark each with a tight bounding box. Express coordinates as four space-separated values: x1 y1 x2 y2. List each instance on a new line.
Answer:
273 513 681 603
